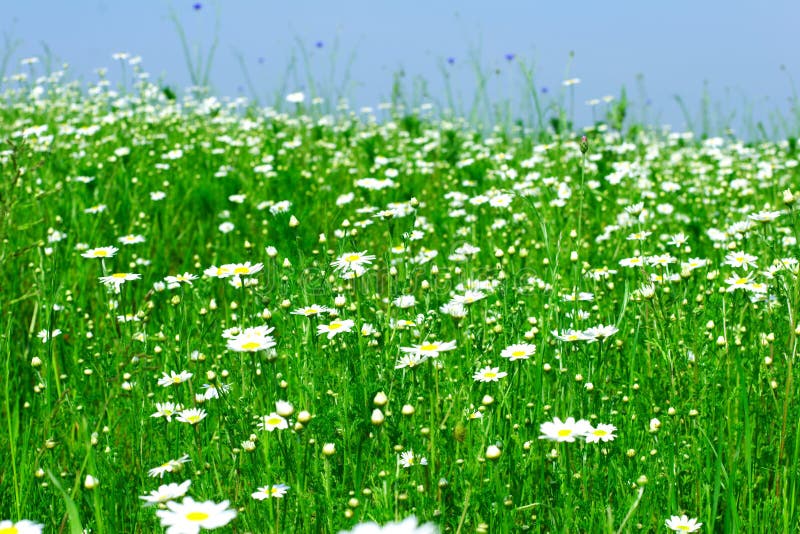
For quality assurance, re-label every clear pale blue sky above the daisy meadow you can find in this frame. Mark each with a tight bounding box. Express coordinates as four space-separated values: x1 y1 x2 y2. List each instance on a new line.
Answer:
0 0 800 135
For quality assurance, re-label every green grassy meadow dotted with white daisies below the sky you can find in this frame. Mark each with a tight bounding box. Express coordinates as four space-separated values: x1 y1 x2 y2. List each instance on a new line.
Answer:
0 56 800 533
